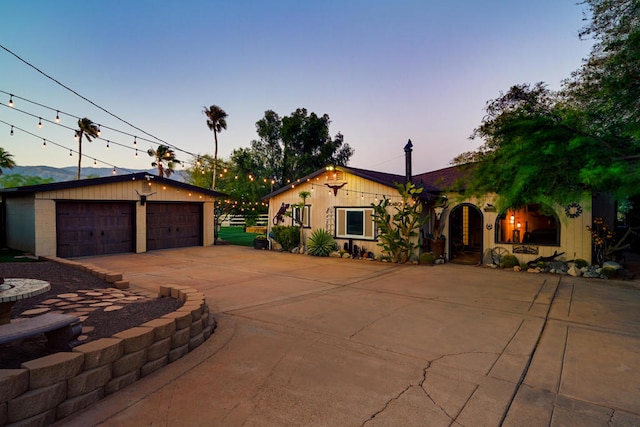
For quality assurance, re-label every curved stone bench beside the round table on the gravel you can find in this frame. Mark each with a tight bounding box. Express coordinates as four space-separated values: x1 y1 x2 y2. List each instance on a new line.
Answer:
0 313 82 351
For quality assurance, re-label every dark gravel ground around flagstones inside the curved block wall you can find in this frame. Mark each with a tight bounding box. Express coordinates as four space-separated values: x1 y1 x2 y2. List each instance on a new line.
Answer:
0 261 182 369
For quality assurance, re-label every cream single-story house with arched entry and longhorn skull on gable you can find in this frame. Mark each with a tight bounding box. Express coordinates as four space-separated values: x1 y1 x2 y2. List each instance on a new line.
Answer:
264 144 615 264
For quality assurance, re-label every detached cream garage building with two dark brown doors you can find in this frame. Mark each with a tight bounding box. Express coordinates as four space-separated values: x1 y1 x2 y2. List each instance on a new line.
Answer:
0 172 224 258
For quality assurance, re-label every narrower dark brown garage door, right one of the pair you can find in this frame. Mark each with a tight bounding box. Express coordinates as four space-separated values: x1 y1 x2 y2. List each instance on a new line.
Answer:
147 203 202 251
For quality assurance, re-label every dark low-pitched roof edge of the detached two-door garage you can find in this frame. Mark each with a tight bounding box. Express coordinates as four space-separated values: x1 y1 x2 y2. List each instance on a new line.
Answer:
0 172 226 197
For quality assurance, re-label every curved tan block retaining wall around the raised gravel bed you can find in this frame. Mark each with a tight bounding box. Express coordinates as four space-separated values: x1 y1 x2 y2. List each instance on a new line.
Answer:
0 258 216 426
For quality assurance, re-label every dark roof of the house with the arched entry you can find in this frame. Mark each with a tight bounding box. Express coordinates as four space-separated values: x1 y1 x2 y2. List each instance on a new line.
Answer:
262 166 463 200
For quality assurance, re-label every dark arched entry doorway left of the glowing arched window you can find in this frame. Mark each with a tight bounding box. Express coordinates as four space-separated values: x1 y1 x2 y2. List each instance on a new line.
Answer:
449 203 482 264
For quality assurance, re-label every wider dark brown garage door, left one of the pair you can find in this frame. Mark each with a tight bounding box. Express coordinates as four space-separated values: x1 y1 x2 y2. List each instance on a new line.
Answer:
56 202 135 258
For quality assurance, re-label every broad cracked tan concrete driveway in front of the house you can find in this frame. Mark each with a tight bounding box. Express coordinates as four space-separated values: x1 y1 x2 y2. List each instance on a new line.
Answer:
60 246 640 426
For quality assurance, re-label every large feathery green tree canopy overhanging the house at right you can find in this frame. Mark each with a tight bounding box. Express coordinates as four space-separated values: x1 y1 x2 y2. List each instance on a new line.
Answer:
453 0 640 205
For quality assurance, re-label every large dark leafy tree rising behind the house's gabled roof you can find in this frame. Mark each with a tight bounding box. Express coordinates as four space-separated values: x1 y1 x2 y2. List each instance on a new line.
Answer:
239 108 353 186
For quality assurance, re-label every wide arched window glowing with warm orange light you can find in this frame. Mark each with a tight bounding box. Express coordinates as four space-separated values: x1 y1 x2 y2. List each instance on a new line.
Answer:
496 204 560 246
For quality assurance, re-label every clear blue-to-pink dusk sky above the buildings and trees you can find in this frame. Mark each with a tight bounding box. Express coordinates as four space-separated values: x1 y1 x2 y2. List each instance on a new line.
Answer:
0 0 592 174
